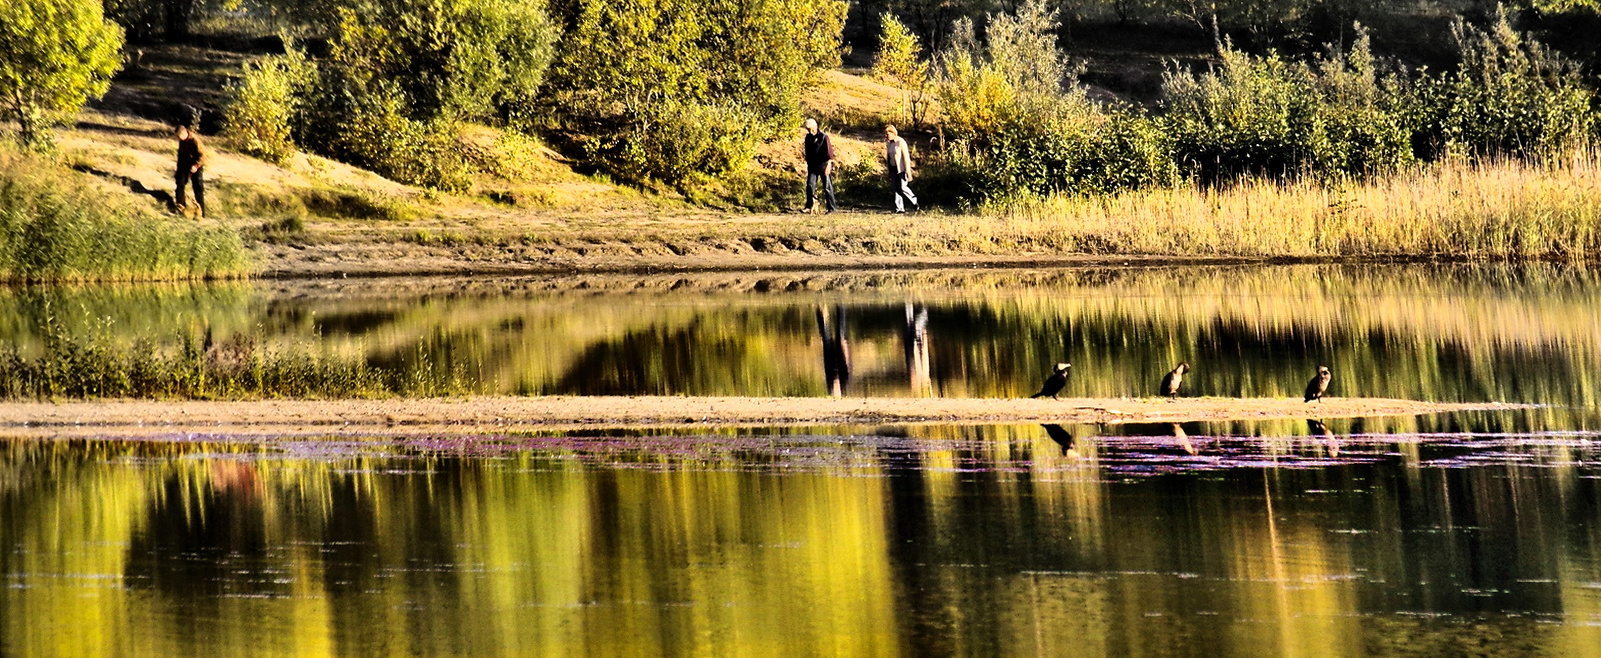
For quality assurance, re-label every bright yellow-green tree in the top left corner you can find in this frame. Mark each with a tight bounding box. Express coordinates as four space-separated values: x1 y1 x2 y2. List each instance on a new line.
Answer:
0 0 122 146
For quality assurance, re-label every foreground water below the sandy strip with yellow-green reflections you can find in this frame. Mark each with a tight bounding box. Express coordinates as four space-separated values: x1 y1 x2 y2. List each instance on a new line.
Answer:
0 421 1601 655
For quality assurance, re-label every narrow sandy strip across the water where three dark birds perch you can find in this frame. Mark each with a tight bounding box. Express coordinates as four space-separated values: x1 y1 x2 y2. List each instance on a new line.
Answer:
0 395 1529 437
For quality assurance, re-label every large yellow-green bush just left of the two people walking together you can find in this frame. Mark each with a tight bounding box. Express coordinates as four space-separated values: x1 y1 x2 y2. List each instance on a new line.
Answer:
552 0 847 184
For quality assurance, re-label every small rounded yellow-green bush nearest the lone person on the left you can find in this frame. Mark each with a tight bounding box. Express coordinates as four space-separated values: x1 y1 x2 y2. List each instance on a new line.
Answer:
224 46 317 165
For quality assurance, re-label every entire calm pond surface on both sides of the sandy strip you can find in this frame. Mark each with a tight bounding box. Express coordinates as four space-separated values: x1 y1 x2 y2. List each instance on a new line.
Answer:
0 266 1601 656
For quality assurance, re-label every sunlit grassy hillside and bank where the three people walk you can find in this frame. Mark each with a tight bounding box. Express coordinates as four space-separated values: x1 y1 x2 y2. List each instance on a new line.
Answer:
15 10 1601 275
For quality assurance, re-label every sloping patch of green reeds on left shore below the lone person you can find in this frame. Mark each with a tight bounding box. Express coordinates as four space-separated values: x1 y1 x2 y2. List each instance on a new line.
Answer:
0 152 248 282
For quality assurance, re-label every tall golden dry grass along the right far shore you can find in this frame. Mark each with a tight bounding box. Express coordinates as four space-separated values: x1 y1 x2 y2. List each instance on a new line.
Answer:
992 150 1601 259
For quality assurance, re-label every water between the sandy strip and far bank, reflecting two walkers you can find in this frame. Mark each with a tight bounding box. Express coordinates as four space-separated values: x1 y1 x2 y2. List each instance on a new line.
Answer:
0 264 1601 423
